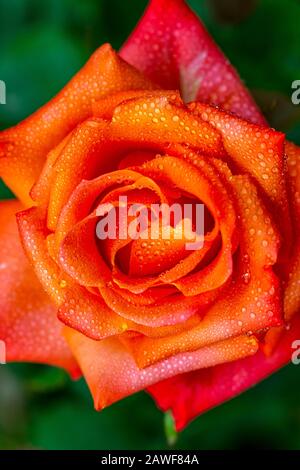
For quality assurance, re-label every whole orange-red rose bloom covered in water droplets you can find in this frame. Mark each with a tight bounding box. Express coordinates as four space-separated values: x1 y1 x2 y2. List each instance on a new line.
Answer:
0 0 300 429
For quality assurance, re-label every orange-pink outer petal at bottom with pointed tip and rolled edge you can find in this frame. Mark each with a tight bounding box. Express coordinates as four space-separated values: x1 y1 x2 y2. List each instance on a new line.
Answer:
65 328 257 409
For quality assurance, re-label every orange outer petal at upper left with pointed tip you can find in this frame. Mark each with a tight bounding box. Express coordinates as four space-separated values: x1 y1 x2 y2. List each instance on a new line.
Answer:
0 44 153 205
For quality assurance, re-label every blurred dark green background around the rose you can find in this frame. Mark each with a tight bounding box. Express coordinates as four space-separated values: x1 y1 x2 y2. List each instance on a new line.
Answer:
0 0 300 449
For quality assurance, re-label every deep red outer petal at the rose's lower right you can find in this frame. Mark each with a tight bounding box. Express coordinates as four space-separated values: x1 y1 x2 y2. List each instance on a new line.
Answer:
148 315 300 431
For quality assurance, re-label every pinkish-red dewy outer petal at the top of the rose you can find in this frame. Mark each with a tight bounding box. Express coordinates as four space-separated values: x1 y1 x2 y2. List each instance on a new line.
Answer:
121 0 265 124
